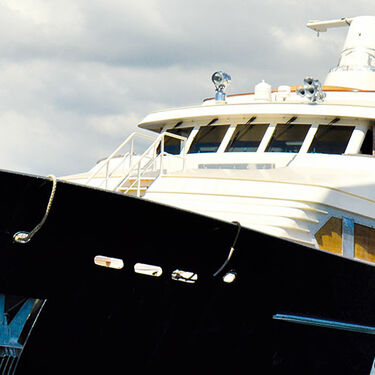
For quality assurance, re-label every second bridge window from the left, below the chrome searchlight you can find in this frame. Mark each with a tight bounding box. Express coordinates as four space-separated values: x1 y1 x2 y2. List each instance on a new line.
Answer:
189 125 229 154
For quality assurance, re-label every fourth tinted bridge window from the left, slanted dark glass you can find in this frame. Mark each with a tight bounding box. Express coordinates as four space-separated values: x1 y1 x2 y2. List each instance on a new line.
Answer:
266 124 311 152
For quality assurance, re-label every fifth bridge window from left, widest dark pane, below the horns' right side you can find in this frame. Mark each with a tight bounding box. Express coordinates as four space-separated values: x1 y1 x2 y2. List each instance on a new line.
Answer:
308 125 354 154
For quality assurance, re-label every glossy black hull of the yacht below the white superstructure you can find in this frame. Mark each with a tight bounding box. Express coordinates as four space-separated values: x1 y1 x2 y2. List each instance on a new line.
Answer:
0 172 375 375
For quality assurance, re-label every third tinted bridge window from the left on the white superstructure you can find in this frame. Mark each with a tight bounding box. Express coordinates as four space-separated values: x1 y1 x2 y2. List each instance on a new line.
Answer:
225 124 268 152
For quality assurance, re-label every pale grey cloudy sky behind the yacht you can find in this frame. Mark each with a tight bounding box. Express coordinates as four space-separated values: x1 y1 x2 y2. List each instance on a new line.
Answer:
0 0 375 176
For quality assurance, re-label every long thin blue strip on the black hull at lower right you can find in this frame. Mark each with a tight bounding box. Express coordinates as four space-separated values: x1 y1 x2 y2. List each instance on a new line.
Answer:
273 314 375 335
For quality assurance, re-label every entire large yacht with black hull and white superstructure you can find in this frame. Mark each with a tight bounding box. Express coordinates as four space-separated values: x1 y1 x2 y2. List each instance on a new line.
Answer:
0 16 375 375
